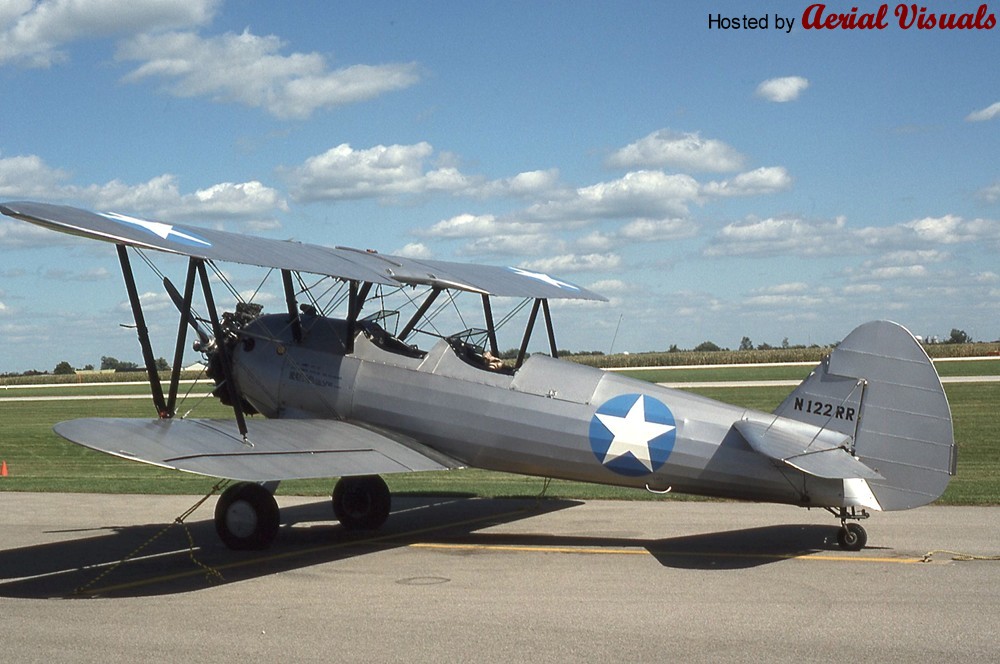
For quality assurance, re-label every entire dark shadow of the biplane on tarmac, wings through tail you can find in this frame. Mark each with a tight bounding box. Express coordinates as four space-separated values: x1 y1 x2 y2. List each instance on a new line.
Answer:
0 496 839 599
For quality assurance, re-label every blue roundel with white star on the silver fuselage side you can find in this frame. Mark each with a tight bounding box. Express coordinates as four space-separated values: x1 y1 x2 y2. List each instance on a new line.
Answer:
590 394 677 477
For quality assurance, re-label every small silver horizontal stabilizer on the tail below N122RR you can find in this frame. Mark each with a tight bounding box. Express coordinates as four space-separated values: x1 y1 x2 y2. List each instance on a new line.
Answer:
734 420 884 480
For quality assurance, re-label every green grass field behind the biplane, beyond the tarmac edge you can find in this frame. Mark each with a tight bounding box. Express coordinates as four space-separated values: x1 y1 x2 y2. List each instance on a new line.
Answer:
0 360 1000 505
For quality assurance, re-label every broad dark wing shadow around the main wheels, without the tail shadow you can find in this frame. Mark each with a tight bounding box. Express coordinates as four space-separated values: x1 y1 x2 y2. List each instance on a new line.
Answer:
0 496 581 599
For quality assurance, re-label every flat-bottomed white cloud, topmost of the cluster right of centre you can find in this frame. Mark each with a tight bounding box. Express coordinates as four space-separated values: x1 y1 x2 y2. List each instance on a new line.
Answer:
607 129 746 172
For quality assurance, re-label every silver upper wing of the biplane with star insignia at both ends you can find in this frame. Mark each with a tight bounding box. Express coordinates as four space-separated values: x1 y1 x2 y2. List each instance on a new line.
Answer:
0 201 606 301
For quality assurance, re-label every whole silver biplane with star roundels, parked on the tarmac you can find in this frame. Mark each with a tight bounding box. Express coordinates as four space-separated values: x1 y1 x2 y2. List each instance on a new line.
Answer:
0 202 956 550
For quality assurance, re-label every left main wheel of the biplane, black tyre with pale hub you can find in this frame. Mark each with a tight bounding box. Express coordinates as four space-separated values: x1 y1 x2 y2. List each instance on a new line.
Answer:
215 482 278 551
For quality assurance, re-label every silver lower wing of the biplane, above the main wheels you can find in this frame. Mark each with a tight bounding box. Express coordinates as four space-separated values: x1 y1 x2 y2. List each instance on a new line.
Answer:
55 418 461 482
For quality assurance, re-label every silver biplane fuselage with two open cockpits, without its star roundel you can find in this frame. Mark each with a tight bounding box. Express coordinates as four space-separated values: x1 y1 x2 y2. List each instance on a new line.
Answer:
233 315 844 506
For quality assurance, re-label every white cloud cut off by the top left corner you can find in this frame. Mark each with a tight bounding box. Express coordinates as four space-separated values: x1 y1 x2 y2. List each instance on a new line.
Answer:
0 0 220 67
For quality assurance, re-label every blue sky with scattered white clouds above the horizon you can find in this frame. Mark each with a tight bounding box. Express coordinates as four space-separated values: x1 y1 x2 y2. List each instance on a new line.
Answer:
0 0 1000 372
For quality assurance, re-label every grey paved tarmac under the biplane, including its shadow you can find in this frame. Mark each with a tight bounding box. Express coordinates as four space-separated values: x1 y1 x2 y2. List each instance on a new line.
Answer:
0 493 1000 662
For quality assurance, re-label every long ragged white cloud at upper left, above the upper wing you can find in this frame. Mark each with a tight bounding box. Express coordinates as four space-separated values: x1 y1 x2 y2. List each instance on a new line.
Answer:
117 30 420 119
